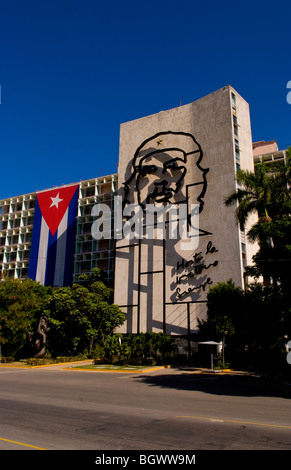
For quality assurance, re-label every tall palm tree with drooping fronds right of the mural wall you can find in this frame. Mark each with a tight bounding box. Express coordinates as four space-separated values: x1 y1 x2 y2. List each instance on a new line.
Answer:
225 153 291 285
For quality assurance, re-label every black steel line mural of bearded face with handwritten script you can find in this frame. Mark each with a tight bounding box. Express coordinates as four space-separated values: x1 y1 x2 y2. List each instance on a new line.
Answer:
117 131 218 330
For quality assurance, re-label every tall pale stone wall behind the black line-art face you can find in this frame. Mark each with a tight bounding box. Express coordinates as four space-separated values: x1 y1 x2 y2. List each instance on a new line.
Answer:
114 86 253 334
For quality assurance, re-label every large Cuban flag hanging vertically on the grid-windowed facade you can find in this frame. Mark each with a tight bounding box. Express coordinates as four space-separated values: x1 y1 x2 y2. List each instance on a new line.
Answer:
28 185 79 287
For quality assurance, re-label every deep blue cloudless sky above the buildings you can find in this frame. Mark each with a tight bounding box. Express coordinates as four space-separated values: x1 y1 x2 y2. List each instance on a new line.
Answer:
0 0 291 199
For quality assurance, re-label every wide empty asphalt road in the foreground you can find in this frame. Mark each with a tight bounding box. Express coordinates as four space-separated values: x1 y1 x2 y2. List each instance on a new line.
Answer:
0 367 291 452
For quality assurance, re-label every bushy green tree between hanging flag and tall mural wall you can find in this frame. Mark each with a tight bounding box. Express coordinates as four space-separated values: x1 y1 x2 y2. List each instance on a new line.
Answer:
49 268 125 355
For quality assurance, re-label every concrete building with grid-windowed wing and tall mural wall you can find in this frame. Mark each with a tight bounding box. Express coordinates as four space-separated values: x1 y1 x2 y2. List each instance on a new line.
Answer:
0 86 286 335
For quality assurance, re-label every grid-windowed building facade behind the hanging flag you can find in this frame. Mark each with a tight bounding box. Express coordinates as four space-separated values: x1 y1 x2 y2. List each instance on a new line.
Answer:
0 174 118 285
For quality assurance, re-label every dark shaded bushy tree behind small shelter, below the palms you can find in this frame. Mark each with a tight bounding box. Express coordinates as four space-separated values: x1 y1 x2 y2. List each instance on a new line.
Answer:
199 280 286 372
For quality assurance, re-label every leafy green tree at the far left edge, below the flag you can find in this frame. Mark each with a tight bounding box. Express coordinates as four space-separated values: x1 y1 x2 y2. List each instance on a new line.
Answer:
0 278 48 356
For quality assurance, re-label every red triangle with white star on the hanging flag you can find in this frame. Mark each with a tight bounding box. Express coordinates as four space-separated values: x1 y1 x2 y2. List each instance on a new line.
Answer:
37 185 78 236
